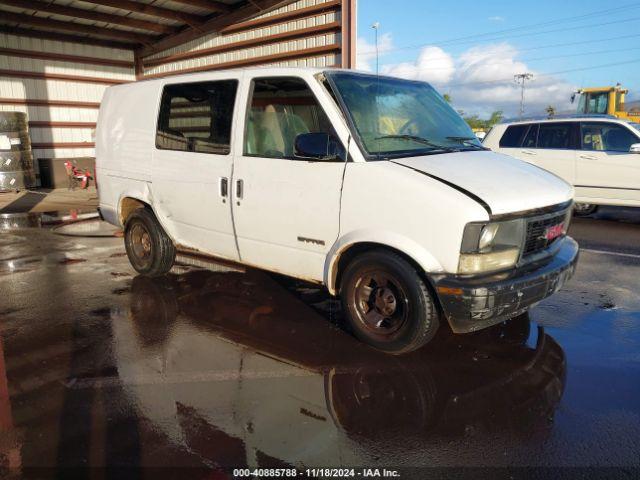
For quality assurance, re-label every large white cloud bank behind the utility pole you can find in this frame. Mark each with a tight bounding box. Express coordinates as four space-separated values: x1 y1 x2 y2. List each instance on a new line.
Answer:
376 37 576 116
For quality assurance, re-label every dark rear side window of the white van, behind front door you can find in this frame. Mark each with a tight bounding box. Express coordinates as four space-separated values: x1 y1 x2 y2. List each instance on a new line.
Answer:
156 80 238 155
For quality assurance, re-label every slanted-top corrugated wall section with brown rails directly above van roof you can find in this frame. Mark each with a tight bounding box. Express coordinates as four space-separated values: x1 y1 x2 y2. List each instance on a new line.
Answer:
143 0 342 77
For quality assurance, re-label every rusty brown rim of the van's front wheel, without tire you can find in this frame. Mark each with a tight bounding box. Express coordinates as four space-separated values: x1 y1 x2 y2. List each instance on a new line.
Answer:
354 271 409 340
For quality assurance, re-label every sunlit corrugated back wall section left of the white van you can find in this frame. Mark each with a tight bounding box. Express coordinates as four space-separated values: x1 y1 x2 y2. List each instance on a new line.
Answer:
0 34 135 166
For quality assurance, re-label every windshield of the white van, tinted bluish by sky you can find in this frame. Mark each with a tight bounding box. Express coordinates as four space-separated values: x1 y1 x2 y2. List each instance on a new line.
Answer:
326 72 485 160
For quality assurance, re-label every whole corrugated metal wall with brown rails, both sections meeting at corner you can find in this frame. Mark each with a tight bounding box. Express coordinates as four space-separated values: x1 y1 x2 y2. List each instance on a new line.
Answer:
0 0 355 181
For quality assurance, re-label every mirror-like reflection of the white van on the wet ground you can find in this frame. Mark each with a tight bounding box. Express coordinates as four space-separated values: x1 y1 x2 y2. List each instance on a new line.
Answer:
111 271 566 468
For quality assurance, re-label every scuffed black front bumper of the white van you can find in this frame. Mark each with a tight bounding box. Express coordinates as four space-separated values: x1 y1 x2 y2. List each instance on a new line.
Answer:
434 237 578 333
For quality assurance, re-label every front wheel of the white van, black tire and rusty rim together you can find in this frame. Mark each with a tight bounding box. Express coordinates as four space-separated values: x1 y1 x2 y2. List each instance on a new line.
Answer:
340 250 440 355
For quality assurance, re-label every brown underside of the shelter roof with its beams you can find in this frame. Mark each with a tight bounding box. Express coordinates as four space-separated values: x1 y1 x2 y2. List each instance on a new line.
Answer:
0 0 290 58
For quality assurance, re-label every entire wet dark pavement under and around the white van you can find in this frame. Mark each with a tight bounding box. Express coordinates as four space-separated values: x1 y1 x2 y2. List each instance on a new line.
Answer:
0 209 640 479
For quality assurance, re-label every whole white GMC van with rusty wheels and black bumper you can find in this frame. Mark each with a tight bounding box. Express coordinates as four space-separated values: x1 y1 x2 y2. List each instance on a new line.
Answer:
96 68 578 353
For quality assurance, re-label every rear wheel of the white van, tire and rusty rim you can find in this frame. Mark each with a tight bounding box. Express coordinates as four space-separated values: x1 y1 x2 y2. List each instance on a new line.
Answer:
124 208 176 277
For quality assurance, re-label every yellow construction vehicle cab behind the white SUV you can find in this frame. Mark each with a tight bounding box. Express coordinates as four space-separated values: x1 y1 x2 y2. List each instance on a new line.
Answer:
571 83 640 121
